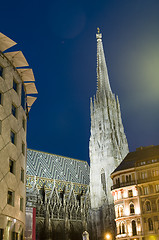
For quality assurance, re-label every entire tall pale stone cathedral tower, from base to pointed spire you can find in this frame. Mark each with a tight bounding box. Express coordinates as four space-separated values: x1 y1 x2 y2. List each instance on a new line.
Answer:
89 32 128 239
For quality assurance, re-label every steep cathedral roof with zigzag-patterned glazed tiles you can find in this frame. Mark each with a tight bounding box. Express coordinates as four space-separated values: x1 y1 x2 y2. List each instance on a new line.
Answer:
26 149 89 185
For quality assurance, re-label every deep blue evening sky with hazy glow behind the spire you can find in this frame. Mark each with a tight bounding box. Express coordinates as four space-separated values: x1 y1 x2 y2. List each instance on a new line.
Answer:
0 0 159 163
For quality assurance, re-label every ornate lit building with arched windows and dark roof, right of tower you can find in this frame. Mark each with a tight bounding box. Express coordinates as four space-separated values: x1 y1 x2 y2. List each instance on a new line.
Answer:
111 145 159 240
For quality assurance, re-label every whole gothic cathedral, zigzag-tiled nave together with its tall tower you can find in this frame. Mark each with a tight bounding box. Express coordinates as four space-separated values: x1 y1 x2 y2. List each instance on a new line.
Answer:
25 29 129 240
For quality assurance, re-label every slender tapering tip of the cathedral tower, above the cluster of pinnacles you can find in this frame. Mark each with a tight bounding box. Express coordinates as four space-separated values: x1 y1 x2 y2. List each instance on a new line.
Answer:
96 28 112 95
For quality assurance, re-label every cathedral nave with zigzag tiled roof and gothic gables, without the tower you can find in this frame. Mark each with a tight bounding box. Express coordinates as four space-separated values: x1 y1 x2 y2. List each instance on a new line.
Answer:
26 150 90 240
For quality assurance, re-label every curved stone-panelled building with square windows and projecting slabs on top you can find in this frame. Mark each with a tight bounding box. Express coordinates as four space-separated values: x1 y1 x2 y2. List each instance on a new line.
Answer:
0 33 37 240
